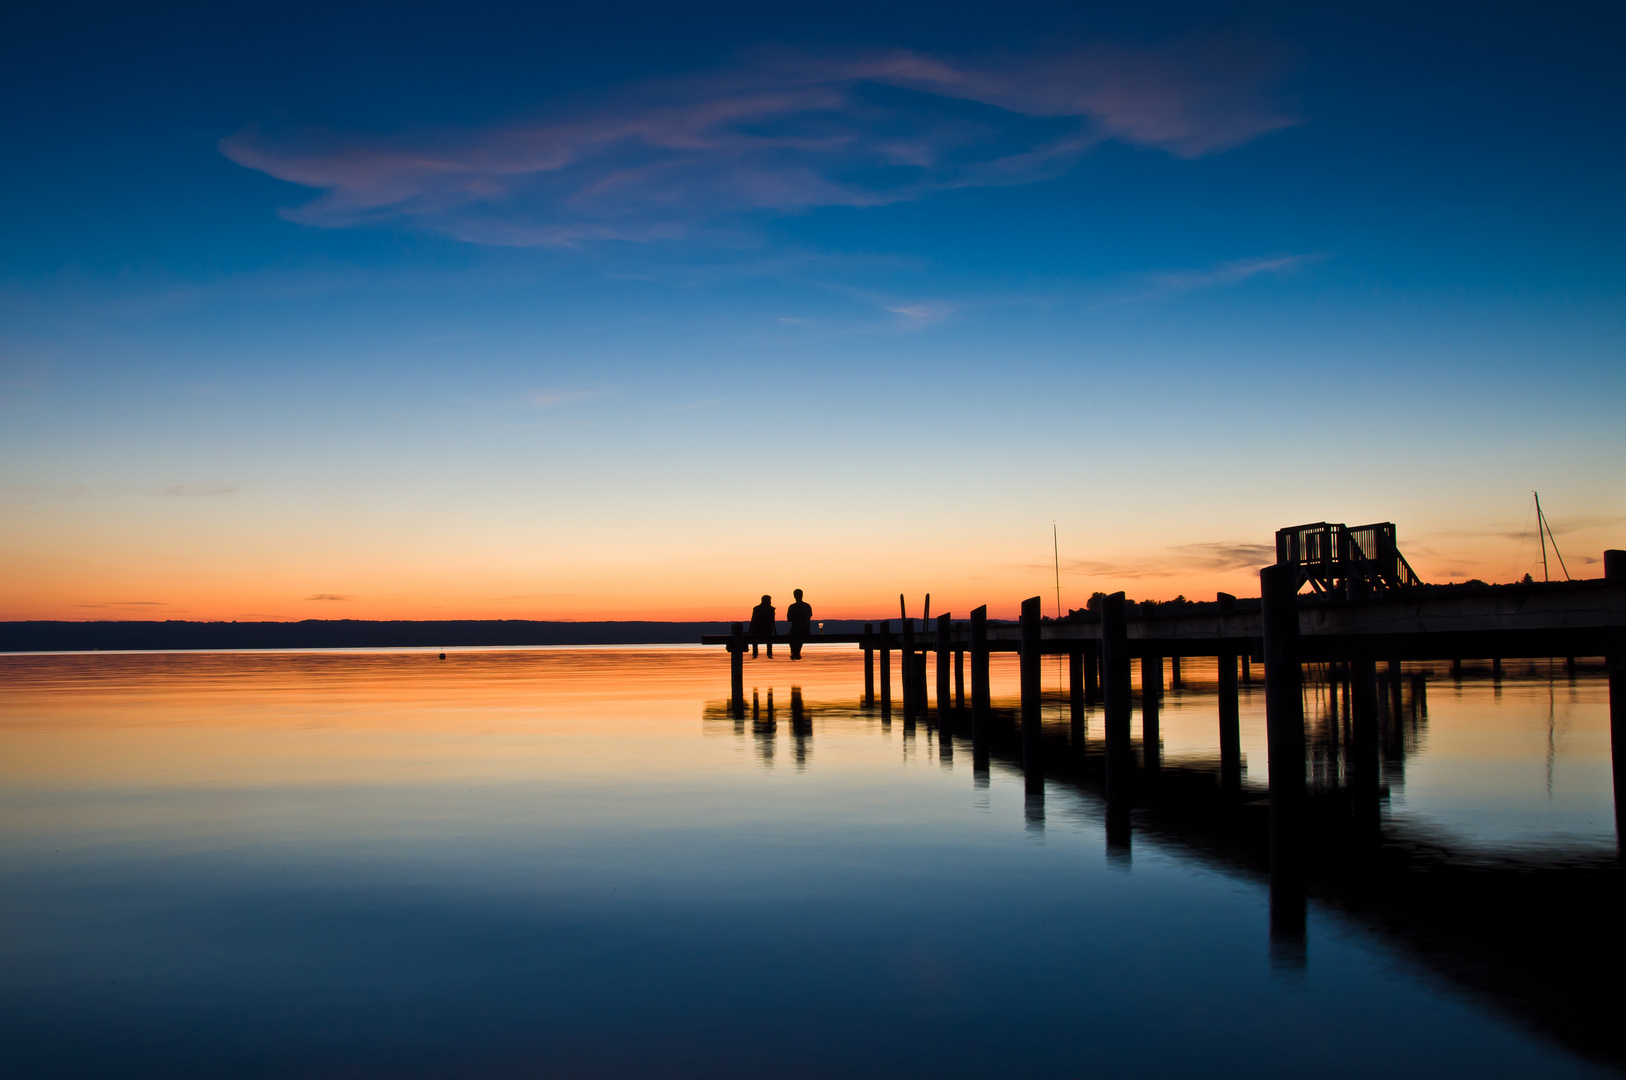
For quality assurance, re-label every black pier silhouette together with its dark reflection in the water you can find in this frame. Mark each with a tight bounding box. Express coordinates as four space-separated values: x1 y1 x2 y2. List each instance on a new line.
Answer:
702 522 1626 1065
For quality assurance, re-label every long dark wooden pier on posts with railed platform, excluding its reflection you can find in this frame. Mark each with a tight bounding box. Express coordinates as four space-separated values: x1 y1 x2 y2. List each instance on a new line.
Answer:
702 522 1626 852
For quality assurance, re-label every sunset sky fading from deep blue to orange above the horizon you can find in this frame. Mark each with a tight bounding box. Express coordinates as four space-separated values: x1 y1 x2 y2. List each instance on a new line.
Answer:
0 2 1626 620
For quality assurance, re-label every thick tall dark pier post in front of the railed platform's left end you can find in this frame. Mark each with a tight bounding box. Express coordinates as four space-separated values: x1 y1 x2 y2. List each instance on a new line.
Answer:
1259 563 1304 872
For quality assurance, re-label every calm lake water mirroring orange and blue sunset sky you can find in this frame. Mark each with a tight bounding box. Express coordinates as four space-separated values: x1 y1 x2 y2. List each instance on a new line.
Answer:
0 649 1621 1077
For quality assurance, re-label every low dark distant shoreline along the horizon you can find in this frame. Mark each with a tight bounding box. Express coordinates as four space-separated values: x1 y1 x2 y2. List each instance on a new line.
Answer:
0 618 904 652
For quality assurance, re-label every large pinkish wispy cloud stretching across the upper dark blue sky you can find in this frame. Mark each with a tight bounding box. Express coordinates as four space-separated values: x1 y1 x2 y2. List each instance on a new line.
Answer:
221 39 1298 246
